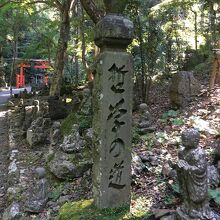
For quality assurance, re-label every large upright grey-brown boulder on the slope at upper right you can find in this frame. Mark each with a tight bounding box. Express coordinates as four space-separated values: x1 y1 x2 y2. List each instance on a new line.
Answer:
170 71 201 108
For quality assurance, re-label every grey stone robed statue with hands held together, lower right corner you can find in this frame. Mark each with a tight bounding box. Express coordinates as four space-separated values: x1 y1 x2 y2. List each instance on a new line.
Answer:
177 129 219 220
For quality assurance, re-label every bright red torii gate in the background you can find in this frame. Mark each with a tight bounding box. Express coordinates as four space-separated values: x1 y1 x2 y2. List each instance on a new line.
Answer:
16 60 50 88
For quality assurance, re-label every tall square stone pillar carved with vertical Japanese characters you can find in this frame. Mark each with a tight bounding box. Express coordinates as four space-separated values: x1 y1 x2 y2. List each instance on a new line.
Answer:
93 0 133 209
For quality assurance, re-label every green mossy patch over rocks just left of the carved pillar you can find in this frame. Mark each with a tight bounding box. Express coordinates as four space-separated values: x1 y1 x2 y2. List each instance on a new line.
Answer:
61 112 92 136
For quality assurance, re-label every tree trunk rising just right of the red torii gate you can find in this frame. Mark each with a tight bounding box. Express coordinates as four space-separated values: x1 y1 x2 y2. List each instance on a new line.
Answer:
50 0 72 96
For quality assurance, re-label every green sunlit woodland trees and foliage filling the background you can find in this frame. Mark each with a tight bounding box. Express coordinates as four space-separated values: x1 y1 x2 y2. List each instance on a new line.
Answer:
0 0 220 99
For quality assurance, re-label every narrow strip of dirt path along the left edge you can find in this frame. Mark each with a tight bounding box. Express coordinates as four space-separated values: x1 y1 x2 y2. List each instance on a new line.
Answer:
0 106 8 216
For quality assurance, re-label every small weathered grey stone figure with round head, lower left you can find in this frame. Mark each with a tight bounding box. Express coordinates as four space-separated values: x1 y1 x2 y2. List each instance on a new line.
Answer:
25 167 48 213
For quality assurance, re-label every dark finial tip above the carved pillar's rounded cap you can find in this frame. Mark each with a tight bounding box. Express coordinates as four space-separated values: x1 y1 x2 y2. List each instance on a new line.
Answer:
103 0 127 14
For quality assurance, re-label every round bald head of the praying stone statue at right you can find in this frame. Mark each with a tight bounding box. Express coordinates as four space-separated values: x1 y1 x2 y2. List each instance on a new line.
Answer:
182 128 200 149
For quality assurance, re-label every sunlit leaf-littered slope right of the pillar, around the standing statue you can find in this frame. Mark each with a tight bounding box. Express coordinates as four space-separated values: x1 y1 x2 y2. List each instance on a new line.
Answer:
129 79 220 219
